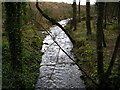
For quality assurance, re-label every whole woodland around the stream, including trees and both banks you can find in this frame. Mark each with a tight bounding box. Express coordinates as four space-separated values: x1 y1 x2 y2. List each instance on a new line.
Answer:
2 0 120 90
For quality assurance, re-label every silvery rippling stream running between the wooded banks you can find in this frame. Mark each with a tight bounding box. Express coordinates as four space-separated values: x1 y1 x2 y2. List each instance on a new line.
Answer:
35 19 85 90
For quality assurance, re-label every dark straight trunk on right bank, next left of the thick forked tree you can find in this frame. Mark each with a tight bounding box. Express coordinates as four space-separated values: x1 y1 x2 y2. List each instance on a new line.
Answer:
86 0 91 35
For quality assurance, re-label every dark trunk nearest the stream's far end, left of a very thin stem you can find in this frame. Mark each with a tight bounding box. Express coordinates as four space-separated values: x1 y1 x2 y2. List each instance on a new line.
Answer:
72 0 77 30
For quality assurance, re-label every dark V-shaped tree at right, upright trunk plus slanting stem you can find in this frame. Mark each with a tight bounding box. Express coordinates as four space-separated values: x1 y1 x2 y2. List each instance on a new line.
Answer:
96 2 120 88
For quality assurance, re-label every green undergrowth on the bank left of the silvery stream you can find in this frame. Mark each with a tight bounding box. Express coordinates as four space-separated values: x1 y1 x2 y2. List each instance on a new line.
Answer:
2 26 44 90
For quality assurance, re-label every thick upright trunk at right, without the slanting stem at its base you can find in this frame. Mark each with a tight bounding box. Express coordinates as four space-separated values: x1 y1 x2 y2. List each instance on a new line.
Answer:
96 2 104 87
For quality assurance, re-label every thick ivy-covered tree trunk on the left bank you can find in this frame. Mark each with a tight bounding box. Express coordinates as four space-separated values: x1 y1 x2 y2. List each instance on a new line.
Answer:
5 2 24 88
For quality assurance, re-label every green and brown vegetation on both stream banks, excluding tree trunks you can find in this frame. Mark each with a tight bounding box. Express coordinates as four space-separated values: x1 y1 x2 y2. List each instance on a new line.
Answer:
2 3 120 89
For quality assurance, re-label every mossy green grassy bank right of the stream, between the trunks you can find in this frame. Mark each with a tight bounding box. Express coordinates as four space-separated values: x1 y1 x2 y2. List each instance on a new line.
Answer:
67 20 120 88
